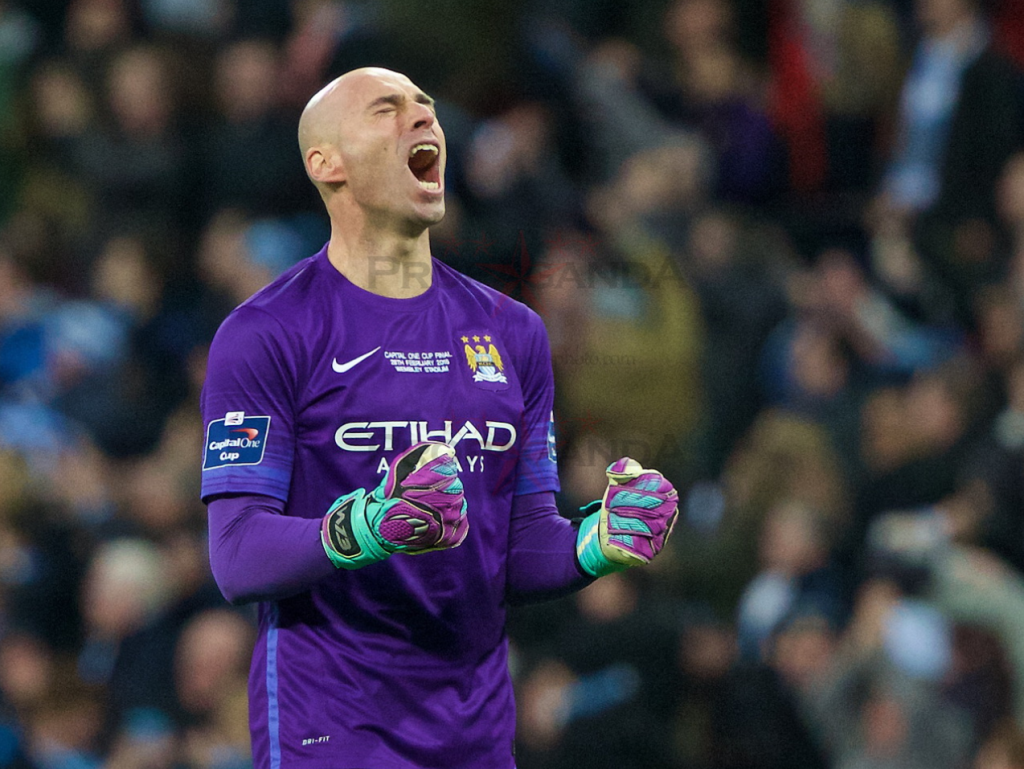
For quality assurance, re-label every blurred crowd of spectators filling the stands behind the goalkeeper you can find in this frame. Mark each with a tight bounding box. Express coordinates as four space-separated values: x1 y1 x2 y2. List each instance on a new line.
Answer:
0 0 1024 769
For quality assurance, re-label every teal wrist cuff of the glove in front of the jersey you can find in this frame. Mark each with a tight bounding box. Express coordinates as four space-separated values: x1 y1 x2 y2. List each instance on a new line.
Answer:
321 488 397 569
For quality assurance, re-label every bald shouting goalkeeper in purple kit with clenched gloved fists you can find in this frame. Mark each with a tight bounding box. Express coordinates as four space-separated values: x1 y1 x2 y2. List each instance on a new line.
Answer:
202 69 677 769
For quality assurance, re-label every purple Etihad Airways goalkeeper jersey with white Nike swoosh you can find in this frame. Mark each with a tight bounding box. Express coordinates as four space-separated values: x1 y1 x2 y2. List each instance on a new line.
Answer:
202 249 558 769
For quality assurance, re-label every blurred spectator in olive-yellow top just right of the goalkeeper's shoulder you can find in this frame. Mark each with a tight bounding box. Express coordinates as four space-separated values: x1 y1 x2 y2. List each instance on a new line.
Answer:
538 143 701 473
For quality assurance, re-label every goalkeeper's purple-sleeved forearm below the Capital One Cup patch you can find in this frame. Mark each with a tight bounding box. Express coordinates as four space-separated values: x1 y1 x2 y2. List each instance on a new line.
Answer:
208 495 336 604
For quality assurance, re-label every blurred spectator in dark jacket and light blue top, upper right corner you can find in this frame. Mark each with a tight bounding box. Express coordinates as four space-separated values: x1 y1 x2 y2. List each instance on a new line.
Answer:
873 0 1024 322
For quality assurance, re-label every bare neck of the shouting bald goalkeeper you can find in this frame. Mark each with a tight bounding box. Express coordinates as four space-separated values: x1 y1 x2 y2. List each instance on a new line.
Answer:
327 205 433 299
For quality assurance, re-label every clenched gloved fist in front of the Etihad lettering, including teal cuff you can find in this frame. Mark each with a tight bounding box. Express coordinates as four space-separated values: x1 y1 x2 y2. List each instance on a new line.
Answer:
321 441 469 569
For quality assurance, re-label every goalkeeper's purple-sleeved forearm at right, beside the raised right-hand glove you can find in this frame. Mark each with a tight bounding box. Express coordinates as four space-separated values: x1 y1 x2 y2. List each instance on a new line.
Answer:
505 492 593 603
